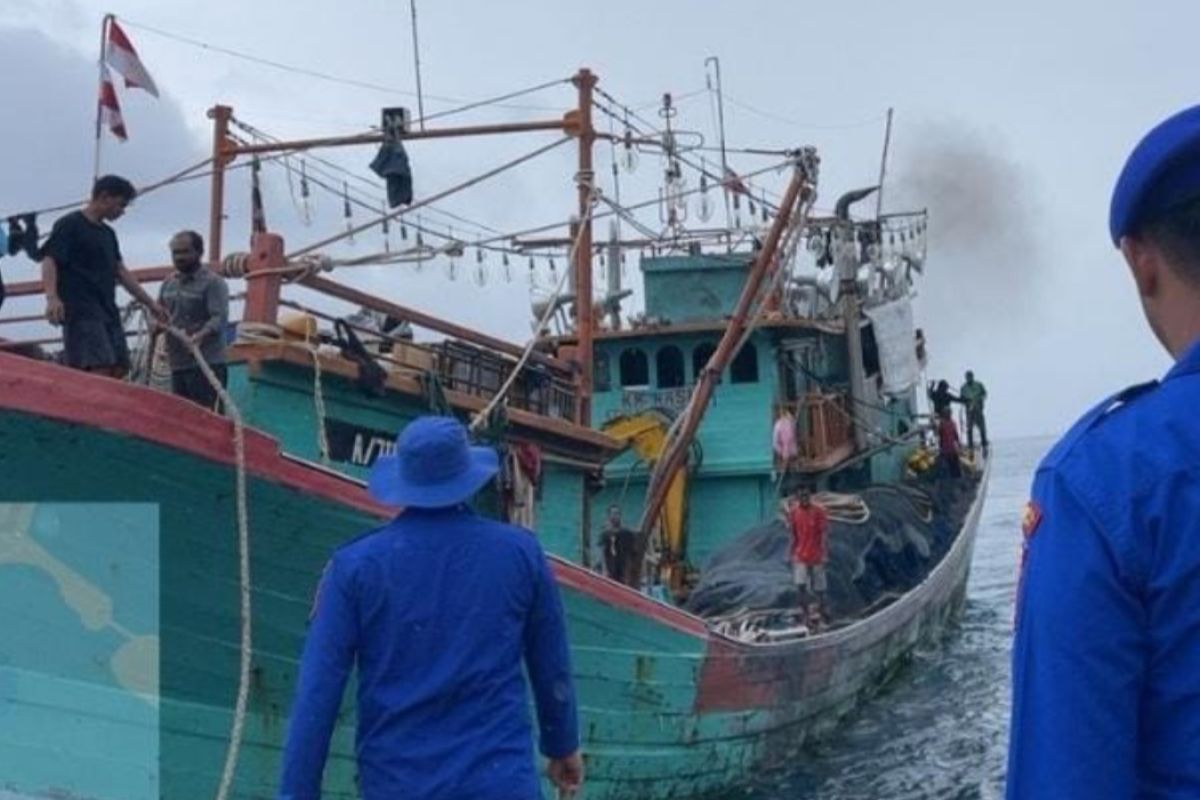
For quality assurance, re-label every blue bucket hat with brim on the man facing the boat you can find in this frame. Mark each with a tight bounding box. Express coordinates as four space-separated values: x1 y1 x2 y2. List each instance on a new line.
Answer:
367 416 499 509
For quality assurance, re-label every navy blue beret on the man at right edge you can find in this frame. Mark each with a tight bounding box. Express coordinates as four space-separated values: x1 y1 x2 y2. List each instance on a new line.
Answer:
1109 106 1200 245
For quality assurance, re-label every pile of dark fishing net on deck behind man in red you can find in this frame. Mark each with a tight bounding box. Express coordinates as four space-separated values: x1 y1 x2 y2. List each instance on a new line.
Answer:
685 477 978 621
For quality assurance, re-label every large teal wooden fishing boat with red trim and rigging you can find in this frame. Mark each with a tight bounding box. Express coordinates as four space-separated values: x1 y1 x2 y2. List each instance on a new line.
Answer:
0 61 986 800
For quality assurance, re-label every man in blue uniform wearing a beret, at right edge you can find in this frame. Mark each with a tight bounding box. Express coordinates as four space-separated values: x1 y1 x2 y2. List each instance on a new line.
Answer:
1008 107 1200 800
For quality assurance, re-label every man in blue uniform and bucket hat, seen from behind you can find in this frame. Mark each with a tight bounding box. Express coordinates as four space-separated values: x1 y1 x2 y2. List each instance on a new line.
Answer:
278 417 583 800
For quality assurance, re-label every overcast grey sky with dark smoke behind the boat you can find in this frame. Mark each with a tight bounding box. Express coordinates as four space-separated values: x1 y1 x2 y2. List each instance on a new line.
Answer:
0 0 1200 437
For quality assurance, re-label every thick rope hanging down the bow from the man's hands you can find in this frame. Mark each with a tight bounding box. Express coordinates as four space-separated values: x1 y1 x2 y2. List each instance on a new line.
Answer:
153 326 253 800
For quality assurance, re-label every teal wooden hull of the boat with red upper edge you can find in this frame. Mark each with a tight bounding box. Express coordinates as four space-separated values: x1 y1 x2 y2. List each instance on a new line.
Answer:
0 355 983 800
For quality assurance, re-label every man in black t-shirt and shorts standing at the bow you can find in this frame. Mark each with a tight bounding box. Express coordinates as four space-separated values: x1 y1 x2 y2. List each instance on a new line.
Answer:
42 175 163 378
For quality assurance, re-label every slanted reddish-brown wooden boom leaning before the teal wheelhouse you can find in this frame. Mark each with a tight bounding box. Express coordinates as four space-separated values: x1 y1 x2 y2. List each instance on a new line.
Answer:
638 150 816 548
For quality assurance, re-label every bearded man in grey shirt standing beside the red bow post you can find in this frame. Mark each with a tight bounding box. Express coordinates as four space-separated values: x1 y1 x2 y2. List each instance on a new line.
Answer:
158 230 229 409
